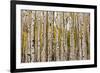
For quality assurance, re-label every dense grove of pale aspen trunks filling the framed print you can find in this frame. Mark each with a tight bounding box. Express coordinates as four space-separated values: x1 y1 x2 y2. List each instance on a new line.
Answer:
21 10 90 63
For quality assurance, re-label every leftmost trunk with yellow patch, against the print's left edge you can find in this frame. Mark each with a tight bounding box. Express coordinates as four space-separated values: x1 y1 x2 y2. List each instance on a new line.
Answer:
21 10 27 62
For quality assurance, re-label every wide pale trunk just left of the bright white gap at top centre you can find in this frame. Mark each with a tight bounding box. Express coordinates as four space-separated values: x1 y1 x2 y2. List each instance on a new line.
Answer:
48 12 53 61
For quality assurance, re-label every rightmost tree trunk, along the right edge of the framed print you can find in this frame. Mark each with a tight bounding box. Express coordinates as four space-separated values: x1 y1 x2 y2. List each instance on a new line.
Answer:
84 13 90 59
